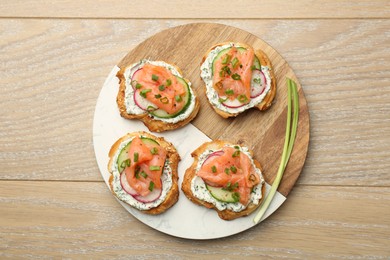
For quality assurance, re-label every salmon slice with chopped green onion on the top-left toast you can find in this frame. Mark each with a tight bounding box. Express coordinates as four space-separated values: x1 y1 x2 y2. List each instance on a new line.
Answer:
132 63 186 114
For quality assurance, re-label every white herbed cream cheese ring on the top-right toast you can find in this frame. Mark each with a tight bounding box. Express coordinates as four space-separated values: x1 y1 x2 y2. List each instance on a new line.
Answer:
200 43 271 114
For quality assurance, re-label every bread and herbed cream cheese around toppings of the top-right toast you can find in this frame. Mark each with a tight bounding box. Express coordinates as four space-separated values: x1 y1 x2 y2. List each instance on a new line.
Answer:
201 42 276 118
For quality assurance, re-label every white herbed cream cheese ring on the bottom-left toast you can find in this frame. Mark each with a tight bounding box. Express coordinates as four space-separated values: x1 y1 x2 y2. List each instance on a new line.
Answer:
111 138 173 210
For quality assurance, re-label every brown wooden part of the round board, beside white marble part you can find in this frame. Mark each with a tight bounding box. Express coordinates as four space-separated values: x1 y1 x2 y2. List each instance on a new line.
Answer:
118 23 309 196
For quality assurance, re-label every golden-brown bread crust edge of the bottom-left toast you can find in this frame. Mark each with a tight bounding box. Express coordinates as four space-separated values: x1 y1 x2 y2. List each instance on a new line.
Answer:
108 131 180 215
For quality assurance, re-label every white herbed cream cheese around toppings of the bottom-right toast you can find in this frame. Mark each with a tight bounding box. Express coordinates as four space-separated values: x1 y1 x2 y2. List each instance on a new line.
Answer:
191 146 265 212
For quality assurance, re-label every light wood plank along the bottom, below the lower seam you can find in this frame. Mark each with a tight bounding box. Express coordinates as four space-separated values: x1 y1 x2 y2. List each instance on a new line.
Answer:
0 181 390 259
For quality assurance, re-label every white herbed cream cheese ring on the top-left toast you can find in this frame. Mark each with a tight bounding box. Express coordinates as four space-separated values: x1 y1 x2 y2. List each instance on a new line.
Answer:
124 59 195 123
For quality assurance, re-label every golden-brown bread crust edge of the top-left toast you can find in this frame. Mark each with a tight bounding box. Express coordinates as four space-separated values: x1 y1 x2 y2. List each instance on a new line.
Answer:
116 62 200 132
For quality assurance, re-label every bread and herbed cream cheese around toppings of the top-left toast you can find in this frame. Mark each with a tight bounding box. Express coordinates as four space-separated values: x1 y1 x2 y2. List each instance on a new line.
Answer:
116 60 200 132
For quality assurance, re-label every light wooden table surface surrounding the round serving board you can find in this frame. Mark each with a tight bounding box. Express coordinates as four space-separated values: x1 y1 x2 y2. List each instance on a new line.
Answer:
0 0 390 259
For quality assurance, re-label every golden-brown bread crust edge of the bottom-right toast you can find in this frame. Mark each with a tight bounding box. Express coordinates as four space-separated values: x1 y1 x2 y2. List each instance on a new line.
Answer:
181 140 265 220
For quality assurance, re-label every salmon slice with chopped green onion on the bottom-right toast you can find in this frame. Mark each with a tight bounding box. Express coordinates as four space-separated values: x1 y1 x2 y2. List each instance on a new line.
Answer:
196 146 260 205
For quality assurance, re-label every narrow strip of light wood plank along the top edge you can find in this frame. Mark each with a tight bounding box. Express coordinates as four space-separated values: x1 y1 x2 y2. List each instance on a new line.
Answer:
0 0 390 19
